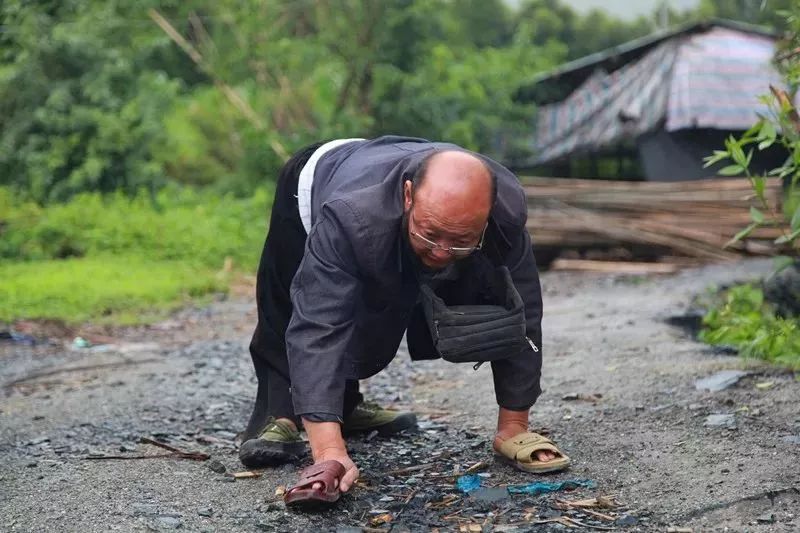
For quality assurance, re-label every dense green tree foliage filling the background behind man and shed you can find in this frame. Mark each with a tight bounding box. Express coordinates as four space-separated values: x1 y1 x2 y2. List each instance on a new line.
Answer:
0 0 786 202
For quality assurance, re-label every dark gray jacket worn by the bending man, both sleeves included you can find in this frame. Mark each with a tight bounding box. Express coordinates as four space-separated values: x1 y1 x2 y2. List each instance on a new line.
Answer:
286 137 542 416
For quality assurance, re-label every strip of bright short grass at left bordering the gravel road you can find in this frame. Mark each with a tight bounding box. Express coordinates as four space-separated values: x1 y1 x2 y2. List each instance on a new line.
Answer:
0 256 228 324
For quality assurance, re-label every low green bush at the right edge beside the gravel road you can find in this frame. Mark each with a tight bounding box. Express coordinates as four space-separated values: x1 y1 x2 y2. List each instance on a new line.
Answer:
700 284 800 370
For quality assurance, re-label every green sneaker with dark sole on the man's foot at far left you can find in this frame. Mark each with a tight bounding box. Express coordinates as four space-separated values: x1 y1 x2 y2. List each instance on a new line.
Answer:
239 418 306 468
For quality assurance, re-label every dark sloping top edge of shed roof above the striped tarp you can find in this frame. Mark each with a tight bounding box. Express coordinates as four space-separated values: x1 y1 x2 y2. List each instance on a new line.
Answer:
515 19 778 105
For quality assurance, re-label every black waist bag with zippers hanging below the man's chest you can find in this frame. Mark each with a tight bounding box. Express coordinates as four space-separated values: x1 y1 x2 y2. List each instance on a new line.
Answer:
420 266 530 363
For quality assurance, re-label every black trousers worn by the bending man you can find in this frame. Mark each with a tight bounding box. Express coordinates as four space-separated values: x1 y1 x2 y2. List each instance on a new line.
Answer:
244 142 362 440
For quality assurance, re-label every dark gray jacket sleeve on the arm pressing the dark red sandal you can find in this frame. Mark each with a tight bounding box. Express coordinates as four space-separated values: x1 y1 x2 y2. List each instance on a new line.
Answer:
286 203 361 417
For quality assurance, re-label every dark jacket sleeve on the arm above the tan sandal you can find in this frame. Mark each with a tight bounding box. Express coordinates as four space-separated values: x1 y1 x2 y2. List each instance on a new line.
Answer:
492 225 542 411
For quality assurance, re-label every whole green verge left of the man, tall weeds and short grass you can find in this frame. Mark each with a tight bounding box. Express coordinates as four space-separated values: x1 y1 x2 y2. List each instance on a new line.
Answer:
0 183 271 324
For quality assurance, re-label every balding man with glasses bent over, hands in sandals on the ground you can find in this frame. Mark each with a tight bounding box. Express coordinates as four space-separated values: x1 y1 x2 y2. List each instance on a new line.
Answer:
240 136 569 501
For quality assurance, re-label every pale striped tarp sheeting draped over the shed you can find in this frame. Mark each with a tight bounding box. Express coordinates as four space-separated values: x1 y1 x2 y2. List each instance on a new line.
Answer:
532 23 783 164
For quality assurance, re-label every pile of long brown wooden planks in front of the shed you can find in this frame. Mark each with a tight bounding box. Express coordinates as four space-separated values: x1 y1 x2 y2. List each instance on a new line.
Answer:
522 178 785 270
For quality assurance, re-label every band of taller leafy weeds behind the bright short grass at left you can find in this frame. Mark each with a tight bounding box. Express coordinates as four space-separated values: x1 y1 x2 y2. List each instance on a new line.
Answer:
0 187 271 270
